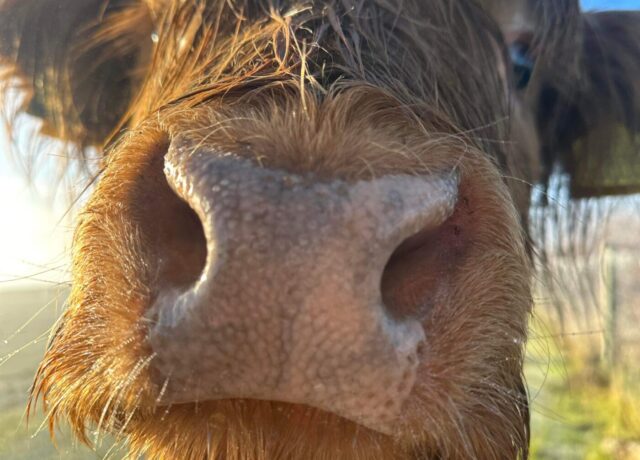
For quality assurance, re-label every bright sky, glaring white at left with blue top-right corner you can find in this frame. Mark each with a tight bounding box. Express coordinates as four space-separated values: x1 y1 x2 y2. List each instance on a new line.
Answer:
0 0 640 289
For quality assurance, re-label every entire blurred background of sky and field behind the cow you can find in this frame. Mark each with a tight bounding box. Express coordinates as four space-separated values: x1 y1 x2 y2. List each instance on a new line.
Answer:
0 0 640 460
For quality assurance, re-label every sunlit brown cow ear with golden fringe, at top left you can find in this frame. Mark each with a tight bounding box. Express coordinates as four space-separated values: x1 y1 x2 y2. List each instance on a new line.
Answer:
0 0 152 146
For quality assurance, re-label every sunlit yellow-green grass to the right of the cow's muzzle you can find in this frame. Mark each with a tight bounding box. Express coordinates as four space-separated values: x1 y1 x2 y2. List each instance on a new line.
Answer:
525 314 640 460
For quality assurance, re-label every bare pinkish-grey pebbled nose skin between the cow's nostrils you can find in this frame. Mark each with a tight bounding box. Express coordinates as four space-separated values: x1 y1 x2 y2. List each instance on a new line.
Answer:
148 139 457 433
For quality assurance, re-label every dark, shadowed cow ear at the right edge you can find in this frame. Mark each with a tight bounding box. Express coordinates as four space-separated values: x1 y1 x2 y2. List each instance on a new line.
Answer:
538 11 640 198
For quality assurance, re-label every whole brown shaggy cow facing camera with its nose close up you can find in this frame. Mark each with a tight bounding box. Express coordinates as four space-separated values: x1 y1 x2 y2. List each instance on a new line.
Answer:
0 0 640 460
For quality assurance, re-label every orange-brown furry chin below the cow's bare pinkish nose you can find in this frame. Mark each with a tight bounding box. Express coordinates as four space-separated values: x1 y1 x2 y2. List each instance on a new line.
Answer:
125 399 402 460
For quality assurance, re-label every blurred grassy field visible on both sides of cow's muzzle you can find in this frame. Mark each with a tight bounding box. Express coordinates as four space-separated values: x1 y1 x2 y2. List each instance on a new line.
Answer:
0 289 640 460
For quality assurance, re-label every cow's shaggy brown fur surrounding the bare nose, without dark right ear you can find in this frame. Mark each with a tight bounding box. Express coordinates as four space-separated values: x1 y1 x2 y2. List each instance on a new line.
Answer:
0 0 636 460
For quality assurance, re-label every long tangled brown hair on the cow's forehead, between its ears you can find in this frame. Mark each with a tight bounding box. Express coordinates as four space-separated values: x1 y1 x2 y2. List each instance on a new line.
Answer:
150 0 506 124
